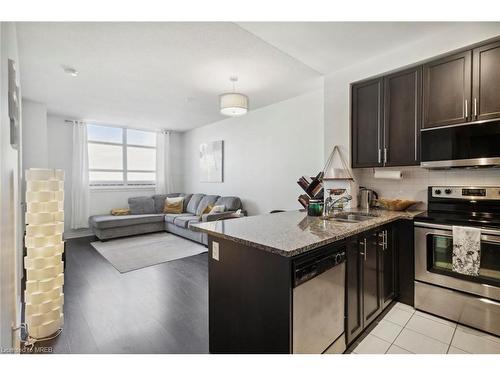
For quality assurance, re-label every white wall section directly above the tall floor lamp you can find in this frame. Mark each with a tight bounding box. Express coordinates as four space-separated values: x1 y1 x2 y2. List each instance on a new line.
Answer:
22 99 48 169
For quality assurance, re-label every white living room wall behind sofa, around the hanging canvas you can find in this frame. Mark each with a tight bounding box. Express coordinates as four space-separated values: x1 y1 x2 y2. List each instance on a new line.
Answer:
183 90 323 215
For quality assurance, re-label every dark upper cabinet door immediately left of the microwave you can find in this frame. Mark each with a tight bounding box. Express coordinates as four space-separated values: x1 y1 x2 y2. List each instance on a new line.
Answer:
383 67 422 167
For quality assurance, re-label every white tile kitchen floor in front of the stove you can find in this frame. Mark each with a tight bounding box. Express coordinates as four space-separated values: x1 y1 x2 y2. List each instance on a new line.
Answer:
352 302 500 354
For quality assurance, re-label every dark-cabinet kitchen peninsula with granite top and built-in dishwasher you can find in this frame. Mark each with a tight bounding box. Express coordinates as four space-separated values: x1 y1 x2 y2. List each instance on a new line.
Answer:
192 210 418 353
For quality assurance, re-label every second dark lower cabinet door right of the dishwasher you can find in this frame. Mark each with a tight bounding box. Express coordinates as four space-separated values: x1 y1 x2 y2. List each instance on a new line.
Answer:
360 232 382 327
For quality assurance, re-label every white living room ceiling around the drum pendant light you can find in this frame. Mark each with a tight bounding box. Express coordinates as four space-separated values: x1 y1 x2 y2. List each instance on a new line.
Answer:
18 22 322 131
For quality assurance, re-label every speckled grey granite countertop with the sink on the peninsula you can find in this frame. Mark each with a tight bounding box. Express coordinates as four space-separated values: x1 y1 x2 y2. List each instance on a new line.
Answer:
191 210 422 257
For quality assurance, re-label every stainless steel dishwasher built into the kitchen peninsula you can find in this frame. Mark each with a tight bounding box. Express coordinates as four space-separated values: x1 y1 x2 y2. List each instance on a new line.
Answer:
292 245 346 354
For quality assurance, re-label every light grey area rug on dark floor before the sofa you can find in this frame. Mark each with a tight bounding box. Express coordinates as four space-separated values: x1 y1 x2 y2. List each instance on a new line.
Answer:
91 233 207 273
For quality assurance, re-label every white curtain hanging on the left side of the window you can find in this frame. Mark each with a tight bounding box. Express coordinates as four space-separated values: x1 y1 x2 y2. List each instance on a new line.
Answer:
71 121 89 229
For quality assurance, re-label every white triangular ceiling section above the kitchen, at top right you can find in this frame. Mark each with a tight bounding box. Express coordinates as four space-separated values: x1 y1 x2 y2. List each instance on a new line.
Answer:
238 22 471 74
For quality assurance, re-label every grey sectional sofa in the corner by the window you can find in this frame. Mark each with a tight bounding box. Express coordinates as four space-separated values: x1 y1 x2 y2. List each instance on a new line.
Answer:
89 193 244 245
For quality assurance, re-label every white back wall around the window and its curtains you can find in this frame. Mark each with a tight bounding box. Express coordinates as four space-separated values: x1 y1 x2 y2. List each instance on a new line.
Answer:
47 115 182 238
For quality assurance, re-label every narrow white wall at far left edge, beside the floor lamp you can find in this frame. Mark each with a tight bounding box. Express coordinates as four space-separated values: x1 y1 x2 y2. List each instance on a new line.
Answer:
0 22 23 350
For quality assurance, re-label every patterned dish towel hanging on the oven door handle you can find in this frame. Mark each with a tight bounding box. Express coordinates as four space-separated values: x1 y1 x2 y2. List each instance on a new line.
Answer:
452 226 481 276
